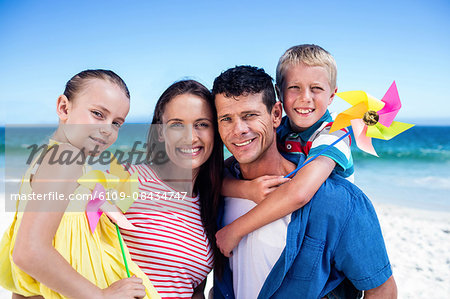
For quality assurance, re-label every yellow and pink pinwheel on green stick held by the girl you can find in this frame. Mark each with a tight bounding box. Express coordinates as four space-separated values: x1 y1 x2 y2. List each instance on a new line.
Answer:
78 158 138 277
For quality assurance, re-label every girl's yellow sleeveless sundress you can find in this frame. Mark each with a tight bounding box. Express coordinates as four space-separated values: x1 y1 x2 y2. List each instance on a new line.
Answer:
0 144 161 299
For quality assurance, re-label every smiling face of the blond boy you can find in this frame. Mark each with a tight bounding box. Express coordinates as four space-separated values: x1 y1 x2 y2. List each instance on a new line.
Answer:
279 63 337 132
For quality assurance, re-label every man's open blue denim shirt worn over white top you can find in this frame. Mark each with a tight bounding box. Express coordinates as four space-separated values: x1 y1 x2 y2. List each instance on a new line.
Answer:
214 156 392 299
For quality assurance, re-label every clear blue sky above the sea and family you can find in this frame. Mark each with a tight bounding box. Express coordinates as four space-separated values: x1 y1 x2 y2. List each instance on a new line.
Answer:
0 1 450 125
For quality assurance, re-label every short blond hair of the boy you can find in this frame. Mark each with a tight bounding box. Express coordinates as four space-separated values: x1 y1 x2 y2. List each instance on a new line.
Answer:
276 44 337 91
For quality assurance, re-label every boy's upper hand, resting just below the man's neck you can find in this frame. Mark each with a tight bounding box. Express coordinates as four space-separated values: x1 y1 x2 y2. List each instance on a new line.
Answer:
248 175 291 203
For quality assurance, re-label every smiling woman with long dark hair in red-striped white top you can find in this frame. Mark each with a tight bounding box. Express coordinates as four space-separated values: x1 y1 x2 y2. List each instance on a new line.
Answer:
123 80 223 298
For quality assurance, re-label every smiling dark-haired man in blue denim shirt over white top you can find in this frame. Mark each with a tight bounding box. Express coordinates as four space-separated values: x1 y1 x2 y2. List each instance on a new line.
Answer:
213 67 397 299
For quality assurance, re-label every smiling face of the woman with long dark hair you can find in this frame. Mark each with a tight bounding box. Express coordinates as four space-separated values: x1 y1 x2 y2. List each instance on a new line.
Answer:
160 94 214 171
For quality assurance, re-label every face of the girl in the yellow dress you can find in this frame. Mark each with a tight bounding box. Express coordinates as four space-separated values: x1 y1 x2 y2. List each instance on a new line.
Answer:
58 79 130 156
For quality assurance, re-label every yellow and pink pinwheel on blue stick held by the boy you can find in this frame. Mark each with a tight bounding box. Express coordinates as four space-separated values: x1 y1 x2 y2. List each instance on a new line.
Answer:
286 81 414 177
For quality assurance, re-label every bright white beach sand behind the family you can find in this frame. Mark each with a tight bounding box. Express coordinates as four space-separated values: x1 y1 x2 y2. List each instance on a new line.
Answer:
0 195 450 299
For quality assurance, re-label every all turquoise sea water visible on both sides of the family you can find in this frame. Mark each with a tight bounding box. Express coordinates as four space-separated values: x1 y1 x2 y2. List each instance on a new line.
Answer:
0 124 450 211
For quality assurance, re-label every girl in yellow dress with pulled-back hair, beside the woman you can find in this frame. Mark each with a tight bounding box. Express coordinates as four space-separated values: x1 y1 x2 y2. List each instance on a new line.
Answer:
0 70 160 299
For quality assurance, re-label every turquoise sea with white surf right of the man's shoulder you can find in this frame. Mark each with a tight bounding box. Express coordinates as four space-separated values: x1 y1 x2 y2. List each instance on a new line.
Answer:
229 126 450 211
